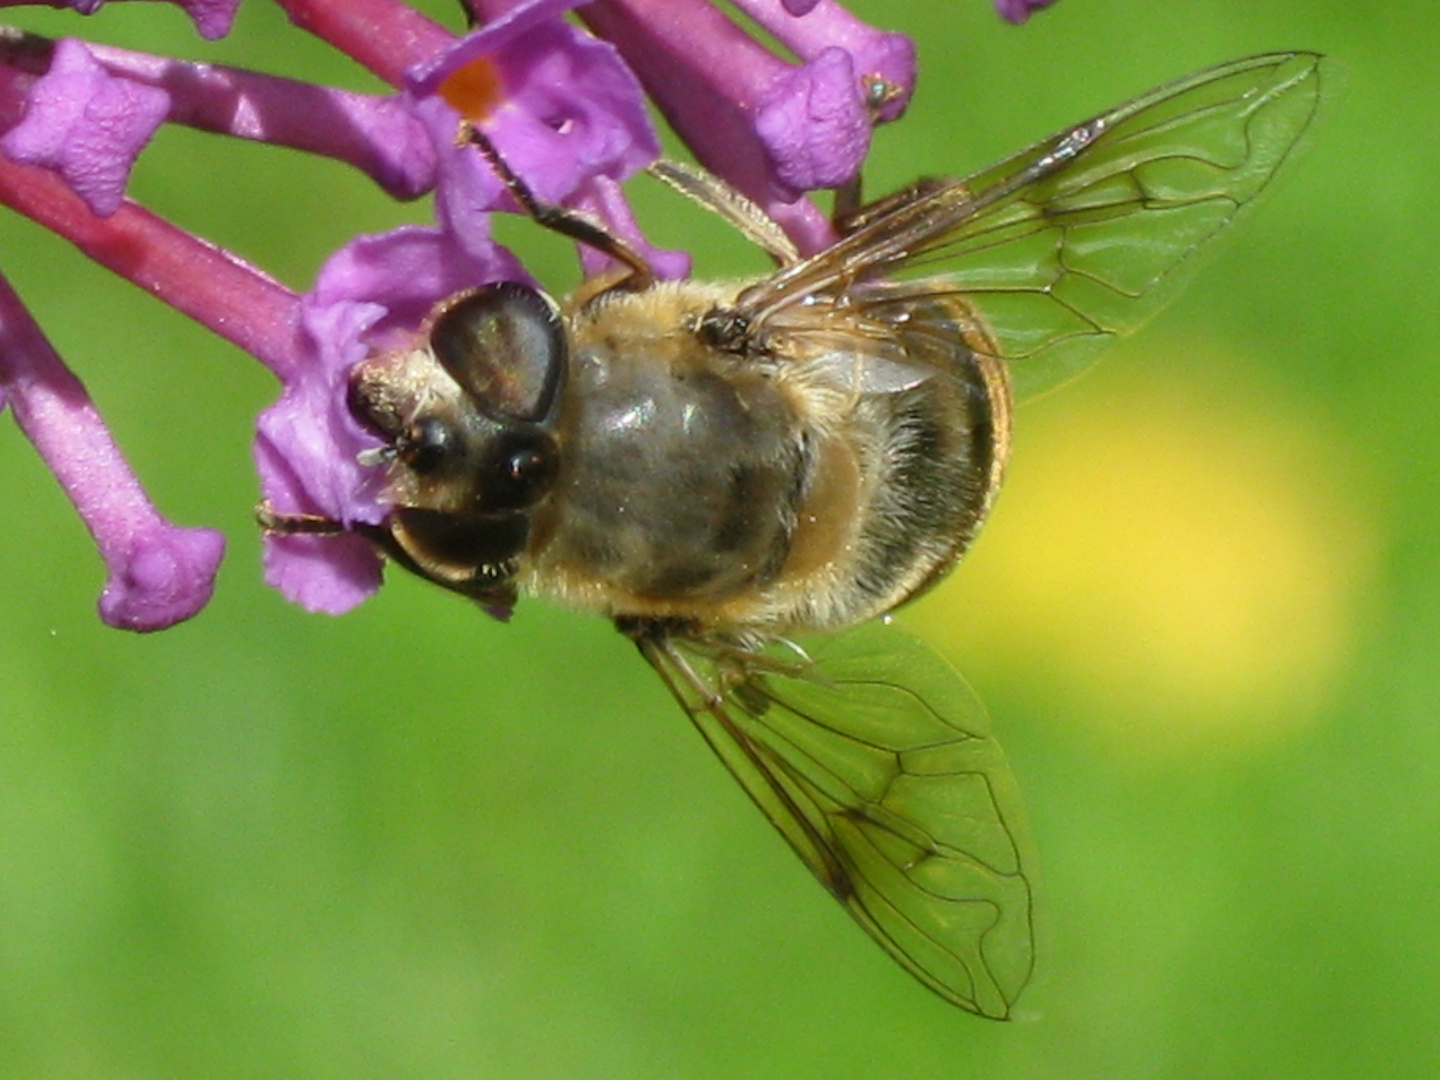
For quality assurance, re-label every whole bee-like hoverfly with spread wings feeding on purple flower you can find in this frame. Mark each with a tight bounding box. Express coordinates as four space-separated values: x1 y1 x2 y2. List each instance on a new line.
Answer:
262 53 1328 1018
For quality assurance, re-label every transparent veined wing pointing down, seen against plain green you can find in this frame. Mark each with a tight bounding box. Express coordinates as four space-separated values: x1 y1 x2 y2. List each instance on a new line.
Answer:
639 622 1034 1018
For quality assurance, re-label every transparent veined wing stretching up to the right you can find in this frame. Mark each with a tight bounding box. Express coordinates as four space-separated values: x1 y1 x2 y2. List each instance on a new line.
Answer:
740 53 1335 397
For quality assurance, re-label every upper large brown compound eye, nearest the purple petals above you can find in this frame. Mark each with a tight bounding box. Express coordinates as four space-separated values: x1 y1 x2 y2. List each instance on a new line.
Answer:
431 281 567 422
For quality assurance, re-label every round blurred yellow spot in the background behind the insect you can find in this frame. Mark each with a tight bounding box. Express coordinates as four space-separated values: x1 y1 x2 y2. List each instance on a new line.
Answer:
909 348 1377 753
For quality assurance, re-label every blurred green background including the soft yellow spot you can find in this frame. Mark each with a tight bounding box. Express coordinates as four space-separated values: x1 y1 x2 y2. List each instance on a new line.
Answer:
0 0 1440 1080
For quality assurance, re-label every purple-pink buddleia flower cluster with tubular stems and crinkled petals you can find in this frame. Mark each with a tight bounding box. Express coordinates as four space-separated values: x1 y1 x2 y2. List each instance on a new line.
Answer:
0 0 1048 631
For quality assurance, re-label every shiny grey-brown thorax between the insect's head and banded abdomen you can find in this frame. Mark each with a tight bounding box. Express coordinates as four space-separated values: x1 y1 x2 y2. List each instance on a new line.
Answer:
533 296 804 618
